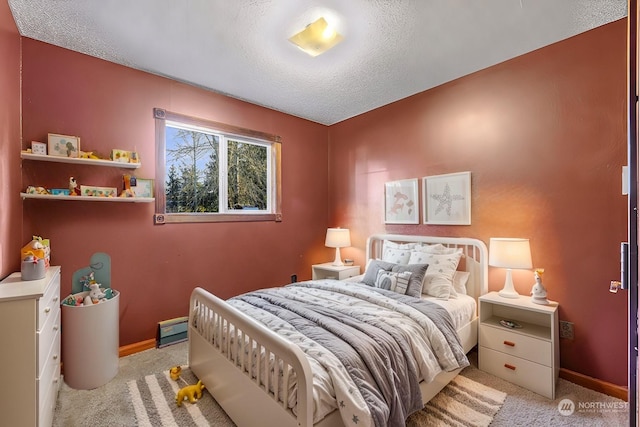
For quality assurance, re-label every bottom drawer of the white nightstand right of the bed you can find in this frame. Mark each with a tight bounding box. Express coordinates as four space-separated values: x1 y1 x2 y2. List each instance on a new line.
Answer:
478 346 555 399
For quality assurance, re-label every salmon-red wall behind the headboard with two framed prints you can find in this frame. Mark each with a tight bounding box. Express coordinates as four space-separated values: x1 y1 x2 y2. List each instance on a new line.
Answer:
329 20 627 385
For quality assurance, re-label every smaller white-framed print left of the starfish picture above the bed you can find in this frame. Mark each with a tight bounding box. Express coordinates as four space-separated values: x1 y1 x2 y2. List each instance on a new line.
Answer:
384 178 420 224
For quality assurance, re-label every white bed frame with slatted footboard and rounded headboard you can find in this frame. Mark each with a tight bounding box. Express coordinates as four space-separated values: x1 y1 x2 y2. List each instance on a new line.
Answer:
188 234 488 427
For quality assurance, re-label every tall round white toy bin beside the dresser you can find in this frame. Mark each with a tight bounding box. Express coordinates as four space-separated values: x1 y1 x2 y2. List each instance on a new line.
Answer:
62 290 120 390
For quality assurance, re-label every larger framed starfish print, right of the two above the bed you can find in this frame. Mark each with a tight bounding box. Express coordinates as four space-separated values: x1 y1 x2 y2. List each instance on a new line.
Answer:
422 172 471 225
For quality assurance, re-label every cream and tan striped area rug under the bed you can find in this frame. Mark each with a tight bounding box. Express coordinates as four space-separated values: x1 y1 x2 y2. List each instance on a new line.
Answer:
127 367 507 427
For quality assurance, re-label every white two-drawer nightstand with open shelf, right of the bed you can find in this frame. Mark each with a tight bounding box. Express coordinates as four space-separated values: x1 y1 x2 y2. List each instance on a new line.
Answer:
478 292 560 399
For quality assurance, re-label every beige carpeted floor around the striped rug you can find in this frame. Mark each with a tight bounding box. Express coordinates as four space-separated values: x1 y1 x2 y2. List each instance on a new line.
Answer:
53 343 629 427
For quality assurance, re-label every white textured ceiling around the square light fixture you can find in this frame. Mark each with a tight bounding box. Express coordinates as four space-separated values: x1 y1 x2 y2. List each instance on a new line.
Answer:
9 0 627 125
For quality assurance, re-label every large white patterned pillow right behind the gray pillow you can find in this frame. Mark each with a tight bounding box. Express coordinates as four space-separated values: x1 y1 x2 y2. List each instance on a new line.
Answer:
409 249 462 299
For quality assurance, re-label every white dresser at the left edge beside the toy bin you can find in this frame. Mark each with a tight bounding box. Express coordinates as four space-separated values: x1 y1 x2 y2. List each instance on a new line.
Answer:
0 266 60 427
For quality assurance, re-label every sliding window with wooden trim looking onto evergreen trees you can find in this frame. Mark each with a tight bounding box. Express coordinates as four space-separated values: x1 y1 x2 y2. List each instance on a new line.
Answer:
154 108 281 223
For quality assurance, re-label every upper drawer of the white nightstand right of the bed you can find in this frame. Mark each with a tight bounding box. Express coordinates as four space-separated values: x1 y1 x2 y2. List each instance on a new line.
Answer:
478 324 553 367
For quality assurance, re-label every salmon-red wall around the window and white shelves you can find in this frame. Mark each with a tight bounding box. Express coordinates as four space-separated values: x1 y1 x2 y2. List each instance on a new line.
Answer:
20 38 330 345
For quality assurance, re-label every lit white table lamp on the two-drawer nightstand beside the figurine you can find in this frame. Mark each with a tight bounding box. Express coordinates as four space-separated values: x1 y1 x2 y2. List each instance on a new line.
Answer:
489 237 533 298
